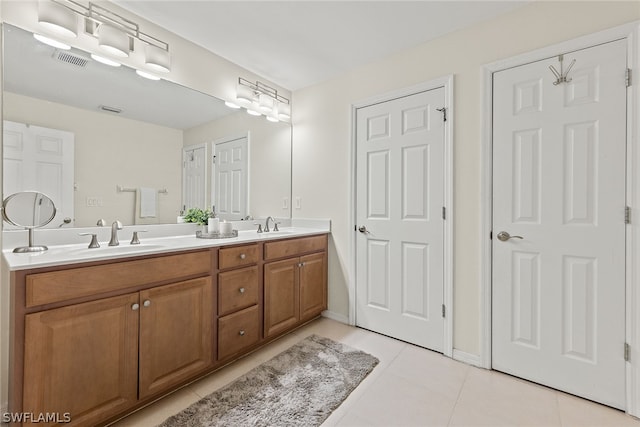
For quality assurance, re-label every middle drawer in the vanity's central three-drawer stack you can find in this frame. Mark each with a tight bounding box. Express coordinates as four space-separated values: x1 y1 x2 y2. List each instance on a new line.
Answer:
218 266 259 316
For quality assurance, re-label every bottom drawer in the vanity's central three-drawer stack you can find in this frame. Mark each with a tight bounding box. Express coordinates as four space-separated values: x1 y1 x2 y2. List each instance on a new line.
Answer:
218 305 260 360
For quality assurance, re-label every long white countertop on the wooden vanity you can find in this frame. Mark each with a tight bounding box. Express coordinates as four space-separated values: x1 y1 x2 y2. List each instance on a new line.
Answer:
2 227 329 271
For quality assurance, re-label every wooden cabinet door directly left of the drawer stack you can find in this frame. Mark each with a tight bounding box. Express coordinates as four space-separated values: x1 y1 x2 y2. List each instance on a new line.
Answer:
140 277 213 399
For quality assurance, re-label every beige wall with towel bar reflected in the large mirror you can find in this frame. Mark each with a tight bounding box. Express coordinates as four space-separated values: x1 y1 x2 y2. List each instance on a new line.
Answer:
3 92 183 227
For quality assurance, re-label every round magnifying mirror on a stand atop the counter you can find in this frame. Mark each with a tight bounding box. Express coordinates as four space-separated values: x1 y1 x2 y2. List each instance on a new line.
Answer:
2 191 56 252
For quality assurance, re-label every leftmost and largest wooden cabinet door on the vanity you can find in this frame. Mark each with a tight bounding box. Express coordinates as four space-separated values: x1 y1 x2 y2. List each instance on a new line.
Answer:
23 293 139 425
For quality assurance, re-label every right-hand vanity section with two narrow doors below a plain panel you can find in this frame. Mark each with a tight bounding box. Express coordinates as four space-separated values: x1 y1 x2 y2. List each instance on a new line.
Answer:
264 235 327 337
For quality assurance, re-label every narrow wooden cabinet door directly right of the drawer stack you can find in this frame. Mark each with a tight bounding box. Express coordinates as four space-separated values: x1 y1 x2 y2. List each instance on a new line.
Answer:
264 258 300 337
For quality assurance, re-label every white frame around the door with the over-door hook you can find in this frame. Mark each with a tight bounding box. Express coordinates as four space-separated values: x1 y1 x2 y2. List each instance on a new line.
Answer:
480 21 640 416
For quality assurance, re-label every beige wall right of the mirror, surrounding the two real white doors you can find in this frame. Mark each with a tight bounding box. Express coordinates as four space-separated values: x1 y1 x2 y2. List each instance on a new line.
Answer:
293 1 640 355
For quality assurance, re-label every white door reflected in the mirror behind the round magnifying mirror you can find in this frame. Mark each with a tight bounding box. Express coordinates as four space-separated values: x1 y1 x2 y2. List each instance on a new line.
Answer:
2 120 75 227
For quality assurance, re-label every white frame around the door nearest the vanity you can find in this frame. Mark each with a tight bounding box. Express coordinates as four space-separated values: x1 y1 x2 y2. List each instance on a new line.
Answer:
348 74 455 357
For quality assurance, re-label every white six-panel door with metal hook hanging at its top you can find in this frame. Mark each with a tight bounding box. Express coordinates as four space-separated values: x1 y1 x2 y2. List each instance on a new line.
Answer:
492 41 627 408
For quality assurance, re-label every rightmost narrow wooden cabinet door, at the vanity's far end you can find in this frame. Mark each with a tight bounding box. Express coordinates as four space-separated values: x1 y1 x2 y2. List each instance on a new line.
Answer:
300 252 327 320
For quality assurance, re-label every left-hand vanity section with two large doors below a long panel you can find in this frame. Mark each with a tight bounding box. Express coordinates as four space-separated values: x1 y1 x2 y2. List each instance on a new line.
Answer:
14 251 214 426
